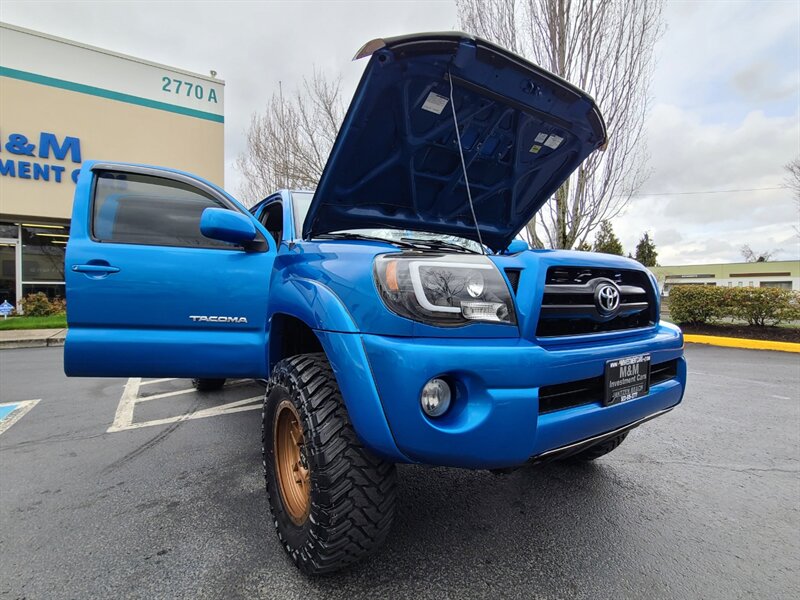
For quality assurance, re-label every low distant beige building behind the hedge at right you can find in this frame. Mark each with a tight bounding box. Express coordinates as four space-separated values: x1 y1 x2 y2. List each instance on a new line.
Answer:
650 260 800 295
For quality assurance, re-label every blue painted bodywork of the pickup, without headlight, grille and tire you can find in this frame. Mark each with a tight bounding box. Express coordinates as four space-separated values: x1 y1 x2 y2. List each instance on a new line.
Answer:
61 34 686 469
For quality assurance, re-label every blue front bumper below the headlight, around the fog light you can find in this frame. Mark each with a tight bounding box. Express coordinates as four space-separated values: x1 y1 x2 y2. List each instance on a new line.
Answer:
360 324 686 468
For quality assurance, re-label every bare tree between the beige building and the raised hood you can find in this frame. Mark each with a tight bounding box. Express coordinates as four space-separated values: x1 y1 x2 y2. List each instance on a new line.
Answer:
236 69 345 205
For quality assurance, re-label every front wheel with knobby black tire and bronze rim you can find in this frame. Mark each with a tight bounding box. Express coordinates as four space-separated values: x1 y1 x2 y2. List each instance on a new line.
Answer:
261 354 397 575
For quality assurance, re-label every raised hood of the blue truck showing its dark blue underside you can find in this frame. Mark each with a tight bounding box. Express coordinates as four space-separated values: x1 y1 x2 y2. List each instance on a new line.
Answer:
303 32 606 251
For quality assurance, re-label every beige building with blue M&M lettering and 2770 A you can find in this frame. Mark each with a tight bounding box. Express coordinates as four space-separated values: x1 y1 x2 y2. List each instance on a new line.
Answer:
0 23 225 305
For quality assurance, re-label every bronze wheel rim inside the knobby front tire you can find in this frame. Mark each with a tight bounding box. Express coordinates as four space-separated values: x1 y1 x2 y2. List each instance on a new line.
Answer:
272 400 311 525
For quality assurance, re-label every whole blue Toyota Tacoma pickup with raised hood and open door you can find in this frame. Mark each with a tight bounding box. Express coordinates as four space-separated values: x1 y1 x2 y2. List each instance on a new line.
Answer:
64 32 686 574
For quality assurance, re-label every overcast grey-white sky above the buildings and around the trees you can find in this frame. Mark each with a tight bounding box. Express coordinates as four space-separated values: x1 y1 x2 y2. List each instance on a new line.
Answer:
0 0 800 265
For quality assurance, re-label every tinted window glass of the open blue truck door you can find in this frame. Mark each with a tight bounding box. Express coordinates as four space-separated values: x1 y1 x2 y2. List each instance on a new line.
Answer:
92 173 235 248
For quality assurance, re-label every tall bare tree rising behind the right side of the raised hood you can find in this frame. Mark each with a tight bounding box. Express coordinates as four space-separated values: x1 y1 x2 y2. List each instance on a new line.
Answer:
456 0 663 248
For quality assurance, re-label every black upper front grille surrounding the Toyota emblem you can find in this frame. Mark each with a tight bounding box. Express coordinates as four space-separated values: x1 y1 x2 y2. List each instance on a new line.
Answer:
536 267 657 337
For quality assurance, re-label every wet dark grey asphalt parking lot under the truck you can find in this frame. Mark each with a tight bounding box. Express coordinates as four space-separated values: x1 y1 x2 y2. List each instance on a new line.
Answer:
0 345 800 600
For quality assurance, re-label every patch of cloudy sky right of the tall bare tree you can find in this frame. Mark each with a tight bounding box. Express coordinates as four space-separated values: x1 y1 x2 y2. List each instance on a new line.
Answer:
614 2 800 264
